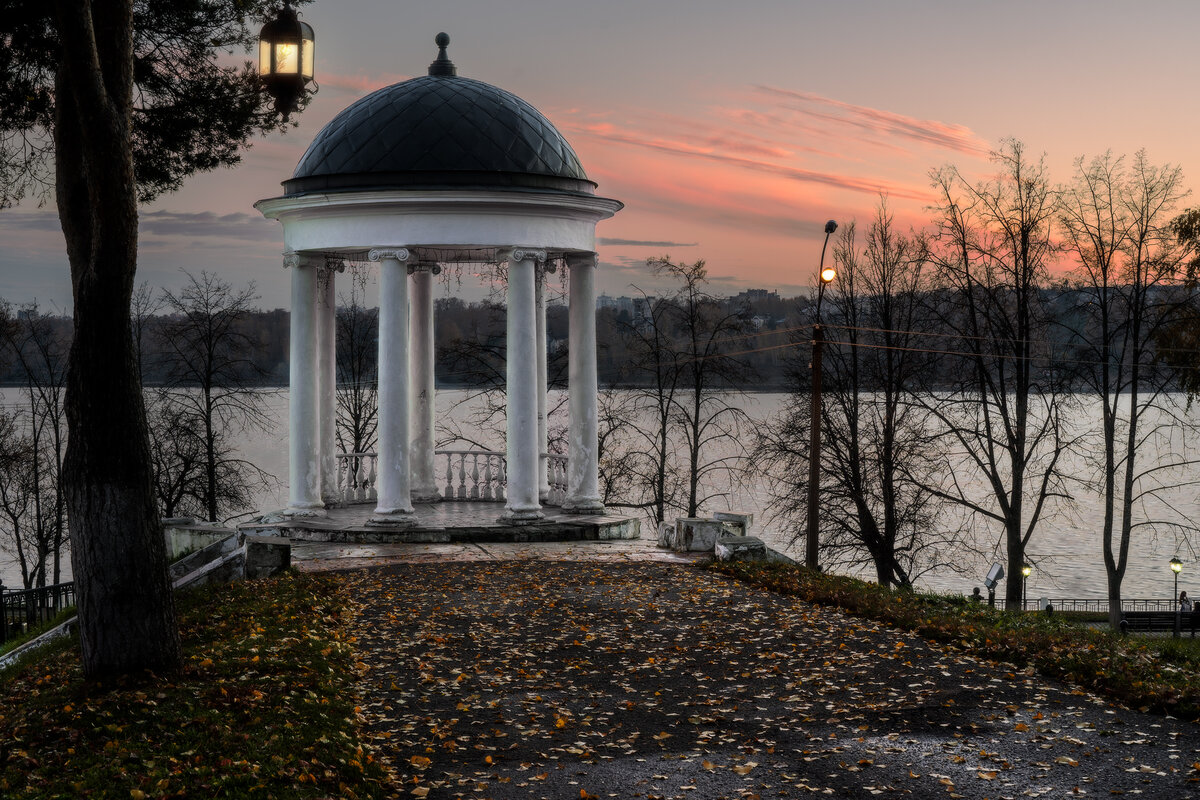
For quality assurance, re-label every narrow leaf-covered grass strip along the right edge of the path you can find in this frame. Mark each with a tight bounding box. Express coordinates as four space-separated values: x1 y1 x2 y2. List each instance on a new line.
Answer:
709 563 1200 720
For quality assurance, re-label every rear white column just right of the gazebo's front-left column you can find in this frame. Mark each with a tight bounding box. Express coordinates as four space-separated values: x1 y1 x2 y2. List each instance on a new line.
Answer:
409 264 442 503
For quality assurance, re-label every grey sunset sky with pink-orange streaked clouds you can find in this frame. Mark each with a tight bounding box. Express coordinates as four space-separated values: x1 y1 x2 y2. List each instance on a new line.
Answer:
0 0 1200 311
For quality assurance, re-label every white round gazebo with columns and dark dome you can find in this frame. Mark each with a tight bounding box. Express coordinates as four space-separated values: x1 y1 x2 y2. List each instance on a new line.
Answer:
254 34 622 525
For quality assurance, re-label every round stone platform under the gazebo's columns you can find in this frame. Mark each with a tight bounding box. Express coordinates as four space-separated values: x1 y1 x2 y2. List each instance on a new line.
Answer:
238 500 641 545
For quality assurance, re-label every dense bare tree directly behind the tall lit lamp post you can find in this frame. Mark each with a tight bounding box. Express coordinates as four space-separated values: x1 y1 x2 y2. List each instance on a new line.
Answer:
756 203 962 587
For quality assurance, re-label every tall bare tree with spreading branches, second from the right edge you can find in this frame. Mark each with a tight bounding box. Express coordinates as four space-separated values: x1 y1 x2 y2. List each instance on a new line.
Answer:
926 140 1072 608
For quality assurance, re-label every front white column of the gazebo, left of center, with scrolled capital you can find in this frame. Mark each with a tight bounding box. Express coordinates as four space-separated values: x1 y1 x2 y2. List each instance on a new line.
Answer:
367 247 413 525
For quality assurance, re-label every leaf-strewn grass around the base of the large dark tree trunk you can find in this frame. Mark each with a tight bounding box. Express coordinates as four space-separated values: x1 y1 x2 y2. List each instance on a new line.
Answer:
0 575 386 800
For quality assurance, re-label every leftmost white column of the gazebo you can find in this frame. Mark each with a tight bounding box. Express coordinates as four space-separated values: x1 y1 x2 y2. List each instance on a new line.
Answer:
283 253 324 516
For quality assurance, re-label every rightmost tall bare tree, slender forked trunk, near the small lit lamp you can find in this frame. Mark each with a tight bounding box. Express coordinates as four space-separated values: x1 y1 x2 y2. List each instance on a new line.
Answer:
1060 152 1195 628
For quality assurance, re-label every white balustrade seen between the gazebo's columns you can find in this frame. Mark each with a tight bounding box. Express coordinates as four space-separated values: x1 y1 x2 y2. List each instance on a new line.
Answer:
337 450 566 505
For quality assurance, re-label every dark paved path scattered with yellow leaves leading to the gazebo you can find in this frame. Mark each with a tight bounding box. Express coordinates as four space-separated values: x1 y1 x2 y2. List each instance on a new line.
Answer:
352 561 1200 800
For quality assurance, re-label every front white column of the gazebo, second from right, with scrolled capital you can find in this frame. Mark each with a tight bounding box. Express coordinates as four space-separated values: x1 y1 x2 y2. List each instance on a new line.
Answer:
499 248 546 523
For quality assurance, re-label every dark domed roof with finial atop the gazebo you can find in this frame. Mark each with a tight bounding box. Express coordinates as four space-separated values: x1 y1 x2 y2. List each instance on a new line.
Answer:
283 36 595 194
